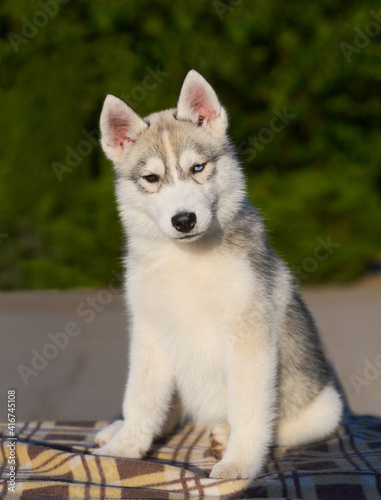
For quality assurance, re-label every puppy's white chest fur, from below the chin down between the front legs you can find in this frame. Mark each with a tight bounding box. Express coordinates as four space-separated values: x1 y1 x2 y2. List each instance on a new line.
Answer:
127 240 253 423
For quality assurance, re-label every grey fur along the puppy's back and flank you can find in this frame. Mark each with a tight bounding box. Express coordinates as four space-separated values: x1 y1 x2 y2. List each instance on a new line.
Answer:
224 200 333 418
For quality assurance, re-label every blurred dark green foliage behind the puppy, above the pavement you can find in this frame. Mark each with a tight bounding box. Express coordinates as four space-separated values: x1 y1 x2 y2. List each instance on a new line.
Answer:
0 0 381 289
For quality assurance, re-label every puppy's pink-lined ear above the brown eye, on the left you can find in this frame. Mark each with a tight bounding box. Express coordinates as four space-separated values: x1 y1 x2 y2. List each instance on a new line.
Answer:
100 94 148 163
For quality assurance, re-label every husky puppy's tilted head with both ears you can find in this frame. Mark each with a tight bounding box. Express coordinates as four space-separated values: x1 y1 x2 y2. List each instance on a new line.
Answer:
100 70 243 242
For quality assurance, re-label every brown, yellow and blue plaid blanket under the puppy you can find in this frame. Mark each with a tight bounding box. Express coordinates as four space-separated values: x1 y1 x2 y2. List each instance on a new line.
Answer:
0 416 381 500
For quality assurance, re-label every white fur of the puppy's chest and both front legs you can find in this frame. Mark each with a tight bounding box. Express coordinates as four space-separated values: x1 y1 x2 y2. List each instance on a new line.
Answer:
97 240 277 477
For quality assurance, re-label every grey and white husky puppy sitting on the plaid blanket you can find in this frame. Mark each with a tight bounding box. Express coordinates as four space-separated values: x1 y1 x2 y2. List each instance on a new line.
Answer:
95 70 342 478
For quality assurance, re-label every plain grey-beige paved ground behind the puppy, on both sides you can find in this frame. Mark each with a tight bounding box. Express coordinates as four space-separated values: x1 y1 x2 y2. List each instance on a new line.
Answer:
0 275 381 421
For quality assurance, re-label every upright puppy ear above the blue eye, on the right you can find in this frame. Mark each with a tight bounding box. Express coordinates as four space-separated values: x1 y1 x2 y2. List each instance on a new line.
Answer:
177 69 228 134
